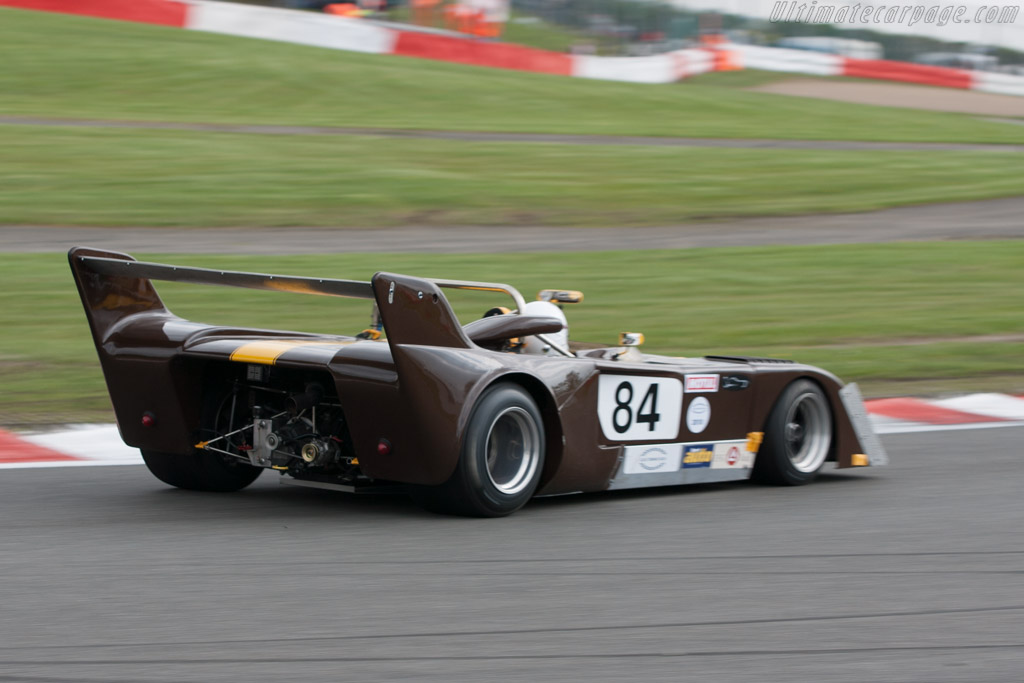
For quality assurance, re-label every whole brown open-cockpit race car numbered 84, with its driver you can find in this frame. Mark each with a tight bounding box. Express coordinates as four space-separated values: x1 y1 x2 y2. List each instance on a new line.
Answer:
69 248 886 516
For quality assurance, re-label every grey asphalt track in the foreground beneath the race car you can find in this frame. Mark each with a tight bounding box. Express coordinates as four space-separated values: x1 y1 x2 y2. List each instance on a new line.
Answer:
0 427 1024 683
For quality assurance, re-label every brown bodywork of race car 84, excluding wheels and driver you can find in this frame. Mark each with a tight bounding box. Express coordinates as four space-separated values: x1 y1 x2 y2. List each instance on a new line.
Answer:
69 248 885 495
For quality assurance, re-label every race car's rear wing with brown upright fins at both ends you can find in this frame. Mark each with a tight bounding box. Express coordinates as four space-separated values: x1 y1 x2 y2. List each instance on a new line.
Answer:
68 247 525 348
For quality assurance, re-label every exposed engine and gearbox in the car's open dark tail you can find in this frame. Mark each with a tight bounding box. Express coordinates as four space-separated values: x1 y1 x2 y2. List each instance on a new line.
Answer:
198 366 359 483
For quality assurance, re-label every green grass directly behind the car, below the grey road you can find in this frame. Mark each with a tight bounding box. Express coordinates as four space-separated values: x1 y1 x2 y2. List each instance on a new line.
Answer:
0 242 1024 424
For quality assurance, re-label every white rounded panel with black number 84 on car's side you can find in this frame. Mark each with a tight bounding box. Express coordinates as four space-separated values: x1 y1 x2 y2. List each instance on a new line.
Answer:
597 375 683 441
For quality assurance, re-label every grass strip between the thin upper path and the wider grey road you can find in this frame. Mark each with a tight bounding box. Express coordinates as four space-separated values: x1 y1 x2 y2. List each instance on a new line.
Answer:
0 126 1024 226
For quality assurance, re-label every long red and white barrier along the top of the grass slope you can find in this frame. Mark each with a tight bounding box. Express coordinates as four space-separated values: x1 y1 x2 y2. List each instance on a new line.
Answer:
0 0 1024 96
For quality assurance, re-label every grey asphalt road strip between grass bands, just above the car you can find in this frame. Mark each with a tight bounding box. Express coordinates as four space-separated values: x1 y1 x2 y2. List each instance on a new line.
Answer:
0 197 1024 254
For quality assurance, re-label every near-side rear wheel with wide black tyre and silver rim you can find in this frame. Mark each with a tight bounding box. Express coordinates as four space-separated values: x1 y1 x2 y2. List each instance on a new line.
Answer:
419 384 545 517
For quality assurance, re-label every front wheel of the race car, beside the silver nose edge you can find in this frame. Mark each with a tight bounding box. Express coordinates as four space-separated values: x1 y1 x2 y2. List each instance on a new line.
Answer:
753 380 833 486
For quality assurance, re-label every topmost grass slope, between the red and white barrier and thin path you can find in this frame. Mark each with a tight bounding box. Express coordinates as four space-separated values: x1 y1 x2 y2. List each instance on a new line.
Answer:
0 9 1024 142
